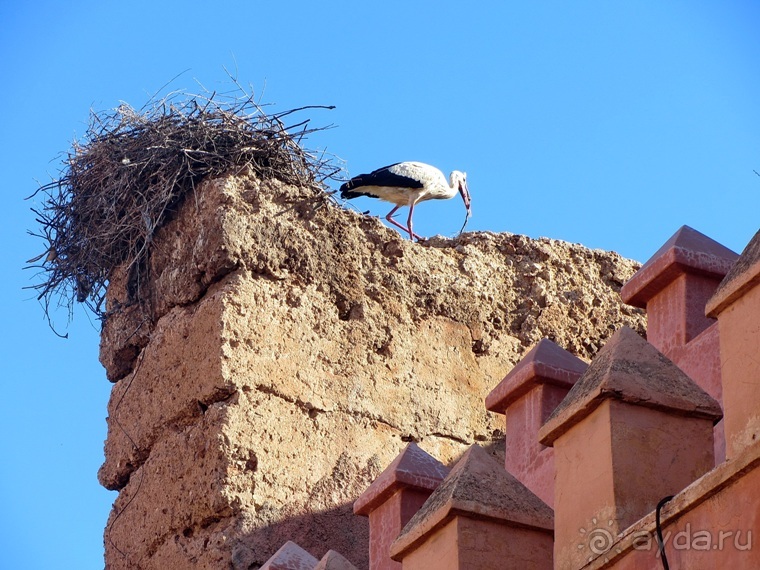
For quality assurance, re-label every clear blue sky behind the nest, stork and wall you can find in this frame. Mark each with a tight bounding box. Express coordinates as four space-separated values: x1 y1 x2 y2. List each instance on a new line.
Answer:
0 0 760 569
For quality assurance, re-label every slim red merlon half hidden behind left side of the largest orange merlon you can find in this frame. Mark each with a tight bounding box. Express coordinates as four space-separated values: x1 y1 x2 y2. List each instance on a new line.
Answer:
486 339 588 506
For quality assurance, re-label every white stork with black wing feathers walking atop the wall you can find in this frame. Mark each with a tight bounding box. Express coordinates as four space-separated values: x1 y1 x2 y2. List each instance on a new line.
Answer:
340 162 471 240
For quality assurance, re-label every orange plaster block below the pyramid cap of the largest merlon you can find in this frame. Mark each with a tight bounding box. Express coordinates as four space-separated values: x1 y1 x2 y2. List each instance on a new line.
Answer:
554 400 714 569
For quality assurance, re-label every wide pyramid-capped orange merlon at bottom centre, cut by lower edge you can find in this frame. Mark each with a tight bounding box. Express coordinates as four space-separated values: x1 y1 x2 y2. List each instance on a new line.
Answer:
391 445 554 570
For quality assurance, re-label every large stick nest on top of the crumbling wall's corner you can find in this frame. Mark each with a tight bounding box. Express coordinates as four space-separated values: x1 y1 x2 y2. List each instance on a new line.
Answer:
30 89 340 328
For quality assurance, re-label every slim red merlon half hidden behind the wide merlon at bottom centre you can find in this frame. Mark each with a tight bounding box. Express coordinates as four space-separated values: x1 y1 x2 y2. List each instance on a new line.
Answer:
354 442 449 570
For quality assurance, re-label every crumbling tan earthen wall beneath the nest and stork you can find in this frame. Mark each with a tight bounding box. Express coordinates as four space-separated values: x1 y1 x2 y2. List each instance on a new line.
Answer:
99 168 644 569
